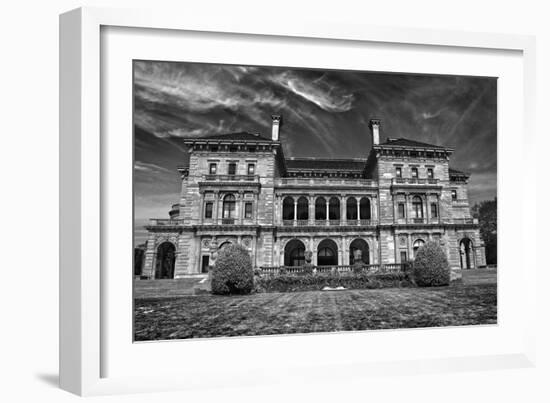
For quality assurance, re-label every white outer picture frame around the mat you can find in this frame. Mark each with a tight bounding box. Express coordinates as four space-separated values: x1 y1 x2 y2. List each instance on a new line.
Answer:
60 8 537 395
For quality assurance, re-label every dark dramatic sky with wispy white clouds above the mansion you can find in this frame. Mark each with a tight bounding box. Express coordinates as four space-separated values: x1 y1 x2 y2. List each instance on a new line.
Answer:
134 61 497 242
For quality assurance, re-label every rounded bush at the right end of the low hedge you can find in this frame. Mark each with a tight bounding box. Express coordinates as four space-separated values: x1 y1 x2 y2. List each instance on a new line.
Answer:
413 241 451 287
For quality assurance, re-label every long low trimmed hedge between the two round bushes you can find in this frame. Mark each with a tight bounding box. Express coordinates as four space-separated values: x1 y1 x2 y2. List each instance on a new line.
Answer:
254 272 413 292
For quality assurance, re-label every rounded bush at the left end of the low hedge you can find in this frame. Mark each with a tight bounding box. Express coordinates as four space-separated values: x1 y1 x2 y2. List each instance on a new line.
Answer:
211 245 254 294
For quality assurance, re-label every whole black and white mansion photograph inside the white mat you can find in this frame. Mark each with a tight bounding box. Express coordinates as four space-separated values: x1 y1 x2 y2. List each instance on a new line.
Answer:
131 60 497 342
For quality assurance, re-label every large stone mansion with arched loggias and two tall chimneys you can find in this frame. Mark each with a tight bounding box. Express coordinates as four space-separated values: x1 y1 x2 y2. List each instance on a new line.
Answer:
142 115 485 279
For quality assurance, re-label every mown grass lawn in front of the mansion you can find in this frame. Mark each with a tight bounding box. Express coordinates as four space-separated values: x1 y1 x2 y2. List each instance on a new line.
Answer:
135 273 497 341
